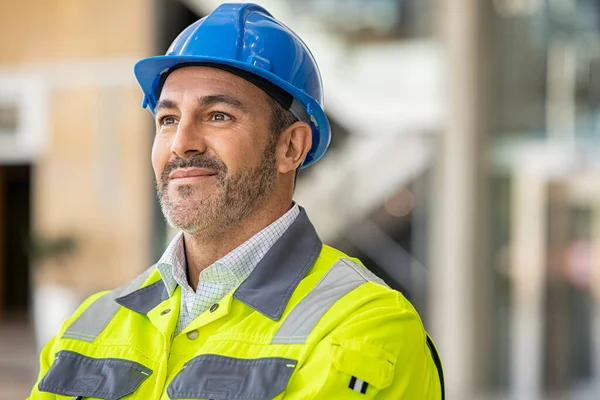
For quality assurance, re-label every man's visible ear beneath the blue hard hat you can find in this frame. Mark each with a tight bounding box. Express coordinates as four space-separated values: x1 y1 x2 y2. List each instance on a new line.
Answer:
277 121 312 174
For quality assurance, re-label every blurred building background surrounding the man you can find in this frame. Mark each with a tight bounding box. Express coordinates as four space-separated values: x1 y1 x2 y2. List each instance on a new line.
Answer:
0 0 600 400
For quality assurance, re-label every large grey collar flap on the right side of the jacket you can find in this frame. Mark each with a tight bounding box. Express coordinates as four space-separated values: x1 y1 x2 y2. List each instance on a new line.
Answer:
233 207 323 321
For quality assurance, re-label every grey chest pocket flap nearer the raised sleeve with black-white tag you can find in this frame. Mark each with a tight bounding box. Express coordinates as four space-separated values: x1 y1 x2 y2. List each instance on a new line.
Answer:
167 354 296 400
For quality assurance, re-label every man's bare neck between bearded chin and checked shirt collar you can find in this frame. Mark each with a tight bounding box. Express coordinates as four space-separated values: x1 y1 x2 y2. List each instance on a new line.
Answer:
183 201 291 290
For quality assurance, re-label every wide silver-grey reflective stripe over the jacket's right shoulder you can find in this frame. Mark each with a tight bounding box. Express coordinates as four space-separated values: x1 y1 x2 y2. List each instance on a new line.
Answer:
271 258 387 344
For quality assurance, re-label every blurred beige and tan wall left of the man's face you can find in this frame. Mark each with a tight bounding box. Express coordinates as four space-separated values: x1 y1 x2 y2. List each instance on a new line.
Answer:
0 0 153 296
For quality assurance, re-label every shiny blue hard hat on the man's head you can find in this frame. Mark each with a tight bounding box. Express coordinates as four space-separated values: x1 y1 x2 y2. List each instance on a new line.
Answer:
134 3 331 168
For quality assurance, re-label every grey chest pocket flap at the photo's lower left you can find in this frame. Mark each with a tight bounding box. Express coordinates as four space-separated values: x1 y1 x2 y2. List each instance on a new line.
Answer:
38 350 152 400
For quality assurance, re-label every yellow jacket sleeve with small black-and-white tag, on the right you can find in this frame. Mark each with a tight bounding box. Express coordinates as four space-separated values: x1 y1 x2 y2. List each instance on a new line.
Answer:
285 291 442 400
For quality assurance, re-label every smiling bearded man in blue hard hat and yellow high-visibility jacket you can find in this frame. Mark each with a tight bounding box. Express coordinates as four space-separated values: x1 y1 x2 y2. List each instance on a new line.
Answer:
31 4 443 400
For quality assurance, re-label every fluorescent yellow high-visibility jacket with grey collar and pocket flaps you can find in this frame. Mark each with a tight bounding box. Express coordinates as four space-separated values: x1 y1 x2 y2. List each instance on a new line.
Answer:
30 210 443 400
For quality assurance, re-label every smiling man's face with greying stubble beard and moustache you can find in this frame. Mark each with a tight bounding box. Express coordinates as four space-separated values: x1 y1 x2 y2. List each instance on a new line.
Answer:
152 66 277 235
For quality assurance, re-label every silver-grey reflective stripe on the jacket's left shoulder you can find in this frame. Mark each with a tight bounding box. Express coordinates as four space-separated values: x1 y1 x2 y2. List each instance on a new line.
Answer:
62 266 154 342
